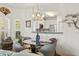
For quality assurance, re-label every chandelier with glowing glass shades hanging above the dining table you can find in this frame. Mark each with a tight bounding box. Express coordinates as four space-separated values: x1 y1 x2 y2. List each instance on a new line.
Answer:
32 4 44 21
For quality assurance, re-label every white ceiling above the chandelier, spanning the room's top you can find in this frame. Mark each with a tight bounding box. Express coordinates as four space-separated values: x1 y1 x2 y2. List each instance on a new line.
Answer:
0 3 79 10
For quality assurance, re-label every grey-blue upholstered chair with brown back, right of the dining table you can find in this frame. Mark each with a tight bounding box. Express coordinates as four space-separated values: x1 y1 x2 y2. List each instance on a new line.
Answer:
40 38 57 56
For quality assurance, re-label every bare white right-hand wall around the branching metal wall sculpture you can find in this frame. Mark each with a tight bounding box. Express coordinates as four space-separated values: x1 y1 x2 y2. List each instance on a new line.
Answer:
57 4 79 55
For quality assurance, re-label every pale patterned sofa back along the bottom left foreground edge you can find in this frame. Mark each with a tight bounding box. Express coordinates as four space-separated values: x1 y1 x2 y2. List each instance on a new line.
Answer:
0 50 40 56
